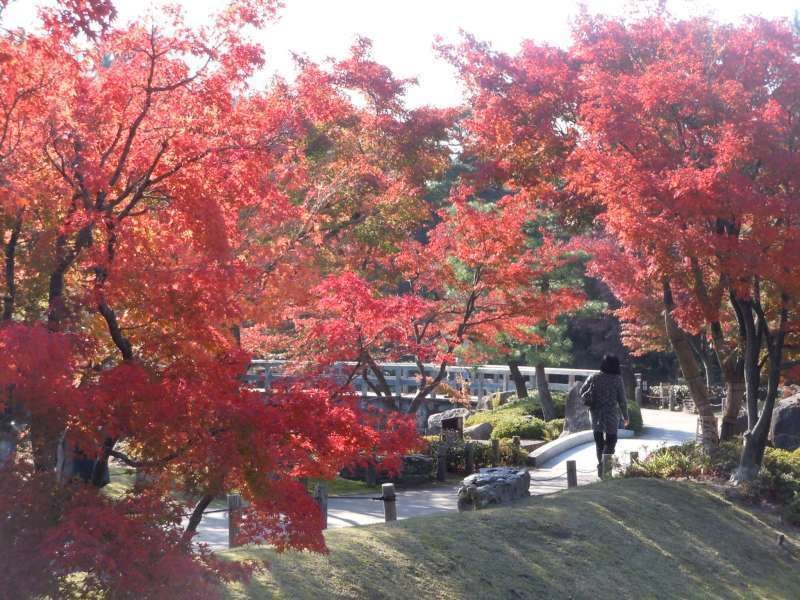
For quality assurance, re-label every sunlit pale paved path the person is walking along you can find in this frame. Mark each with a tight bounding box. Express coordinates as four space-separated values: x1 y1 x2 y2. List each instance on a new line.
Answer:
195 409 697 549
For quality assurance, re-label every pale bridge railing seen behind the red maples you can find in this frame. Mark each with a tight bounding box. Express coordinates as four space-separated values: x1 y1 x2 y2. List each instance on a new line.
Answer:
245 360 596 400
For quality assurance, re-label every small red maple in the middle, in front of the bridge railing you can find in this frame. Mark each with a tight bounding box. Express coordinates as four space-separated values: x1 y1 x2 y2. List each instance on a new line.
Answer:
294 188 582 413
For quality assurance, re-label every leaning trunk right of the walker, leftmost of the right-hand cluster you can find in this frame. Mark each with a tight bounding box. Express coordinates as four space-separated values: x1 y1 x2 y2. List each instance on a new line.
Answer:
664 280 719 448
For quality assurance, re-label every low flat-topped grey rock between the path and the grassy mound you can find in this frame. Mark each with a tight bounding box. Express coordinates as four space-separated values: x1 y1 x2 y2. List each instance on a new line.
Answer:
458 467 531 511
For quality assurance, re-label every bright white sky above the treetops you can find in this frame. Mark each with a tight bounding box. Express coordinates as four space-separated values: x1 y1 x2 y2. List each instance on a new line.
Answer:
3 0 800 106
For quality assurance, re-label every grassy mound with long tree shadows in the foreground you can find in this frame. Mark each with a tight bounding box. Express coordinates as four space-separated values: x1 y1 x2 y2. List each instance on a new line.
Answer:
220 479 800 599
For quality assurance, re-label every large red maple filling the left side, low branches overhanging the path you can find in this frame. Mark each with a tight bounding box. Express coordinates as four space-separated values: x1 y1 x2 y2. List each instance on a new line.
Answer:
0 1 416 597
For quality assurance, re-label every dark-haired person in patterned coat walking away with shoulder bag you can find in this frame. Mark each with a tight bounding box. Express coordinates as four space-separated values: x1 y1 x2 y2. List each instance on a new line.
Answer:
581 354 630 477
